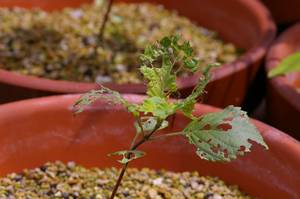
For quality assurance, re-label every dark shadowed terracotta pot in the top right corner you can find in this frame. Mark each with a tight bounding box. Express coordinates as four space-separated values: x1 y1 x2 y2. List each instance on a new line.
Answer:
262 0 300 24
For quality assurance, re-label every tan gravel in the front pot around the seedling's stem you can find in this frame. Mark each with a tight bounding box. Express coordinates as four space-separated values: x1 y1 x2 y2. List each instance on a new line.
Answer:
0 162 251 199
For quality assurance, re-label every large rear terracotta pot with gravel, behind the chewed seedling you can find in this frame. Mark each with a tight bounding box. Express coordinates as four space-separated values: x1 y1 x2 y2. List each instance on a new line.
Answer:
0 0 275 106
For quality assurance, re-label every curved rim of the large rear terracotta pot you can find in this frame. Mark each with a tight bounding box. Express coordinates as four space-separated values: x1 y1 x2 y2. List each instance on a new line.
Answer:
0 0 276 93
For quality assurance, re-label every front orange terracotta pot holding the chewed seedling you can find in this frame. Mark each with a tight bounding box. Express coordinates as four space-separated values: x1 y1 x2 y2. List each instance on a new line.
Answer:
0 95 300 199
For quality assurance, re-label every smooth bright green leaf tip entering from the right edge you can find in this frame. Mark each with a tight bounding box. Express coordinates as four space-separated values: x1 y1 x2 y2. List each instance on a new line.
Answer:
268 52 300 78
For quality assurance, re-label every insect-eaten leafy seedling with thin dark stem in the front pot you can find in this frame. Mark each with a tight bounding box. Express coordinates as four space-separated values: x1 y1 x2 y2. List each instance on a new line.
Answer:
74 36 268 199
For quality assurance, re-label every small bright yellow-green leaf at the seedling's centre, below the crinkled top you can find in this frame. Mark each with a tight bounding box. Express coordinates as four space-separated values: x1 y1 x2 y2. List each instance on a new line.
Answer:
139 96 175 120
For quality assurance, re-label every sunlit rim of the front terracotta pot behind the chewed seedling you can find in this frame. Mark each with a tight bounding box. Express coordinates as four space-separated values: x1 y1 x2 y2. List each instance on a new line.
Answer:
0 94 300 152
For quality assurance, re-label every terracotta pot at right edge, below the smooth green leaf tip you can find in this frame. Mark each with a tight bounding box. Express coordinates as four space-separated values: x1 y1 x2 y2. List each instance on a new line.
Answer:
266 23 300 139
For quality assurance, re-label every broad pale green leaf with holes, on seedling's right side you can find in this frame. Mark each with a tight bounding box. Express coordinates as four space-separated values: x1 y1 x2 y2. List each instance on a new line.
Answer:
183 106 268 161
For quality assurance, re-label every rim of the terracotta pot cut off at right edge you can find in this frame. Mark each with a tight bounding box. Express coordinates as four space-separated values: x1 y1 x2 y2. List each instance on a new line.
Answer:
265 23 300 110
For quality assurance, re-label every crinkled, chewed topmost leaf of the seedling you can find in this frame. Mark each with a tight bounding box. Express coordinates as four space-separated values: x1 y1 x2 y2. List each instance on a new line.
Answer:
140 35 199 97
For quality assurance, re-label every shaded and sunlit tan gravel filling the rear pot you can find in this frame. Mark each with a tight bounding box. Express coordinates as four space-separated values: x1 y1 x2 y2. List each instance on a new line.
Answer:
0 0 239 84
